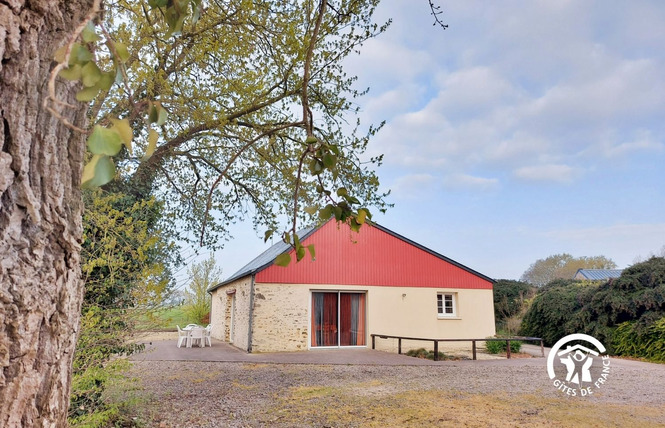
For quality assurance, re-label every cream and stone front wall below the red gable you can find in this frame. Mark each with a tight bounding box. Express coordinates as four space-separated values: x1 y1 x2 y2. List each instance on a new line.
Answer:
249 284 495 352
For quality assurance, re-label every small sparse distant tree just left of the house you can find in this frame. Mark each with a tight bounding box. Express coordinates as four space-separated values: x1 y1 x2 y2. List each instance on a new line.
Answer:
185 255 222 322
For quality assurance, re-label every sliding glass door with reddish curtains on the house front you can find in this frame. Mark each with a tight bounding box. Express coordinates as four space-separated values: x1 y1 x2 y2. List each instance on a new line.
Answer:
312 291 366 347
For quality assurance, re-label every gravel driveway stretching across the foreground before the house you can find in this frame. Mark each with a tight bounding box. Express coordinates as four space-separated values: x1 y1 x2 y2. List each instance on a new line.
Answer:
120 344 665 427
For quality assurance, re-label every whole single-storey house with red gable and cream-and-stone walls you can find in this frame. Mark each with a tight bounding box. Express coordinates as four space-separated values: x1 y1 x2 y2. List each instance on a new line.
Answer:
208 220 495 352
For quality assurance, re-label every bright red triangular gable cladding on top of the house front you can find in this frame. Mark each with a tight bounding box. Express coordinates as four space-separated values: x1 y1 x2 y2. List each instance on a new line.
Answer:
256 221 493 289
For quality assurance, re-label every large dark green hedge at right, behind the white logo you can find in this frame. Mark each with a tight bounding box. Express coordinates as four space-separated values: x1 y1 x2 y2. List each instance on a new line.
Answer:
521 257 665 361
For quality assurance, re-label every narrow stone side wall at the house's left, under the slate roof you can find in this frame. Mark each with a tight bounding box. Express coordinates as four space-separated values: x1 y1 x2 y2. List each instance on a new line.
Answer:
210 276 252 351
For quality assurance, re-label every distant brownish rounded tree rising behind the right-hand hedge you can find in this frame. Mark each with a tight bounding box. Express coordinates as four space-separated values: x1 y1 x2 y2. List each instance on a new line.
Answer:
520 253 617 287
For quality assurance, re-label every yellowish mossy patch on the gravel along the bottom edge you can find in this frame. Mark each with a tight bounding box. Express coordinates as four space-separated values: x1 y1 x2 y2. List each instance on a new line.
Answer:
266 387 665 427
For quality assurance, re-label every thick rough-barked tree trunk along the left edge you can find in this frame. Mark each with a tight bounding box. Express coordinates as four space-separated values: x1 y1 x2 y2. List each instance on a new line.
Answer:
0 0 91 427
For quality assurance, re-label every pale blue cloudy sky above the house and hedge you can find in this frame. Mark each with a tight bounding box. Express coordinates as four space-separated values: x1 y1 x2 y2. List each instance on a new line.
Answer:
179 0 665 288
